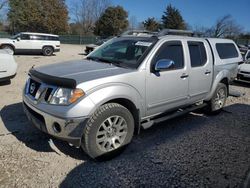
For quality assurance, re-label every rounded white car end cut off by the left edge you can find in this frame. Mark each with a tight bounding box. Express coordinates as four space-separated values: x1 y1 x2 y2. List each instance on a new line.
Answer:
0 50 17 82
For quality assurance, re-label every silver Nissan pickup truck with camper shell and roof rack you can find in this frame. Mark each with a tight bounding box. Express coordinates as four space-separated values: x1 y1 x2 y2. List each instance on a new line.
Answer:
23 32 243 158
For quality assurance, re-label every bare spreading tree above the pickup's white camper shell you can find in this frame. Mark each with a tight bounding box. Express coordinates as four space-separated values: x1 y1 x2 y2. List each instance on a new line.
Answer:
211 15 242 38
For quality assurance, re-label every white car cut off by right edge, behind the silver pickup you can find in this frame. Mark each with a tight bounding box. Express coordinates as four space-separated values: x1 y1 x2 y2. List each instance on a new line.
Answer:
237 50 250 82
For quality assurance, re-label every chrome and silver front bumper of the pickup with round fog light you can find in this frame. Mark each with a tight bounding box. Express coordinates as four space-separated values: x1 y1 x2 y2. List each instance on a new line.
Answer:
23 98 88 147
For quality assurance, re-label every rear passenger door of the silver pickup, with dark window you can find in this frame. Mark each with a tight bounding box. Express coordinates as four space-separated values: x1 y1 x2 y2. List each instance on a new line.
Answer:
186 40 213 103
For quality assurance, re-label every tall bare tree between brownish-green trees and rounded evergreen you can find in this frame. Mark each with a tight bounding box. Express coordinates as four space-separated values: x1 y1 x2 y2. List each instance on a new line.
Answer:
71 0 111 34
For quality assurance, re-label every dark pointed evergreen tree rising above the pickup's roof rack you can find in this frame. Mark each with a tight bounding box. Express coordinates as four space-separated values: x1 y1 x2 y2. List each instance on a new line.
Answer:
162 4 186 30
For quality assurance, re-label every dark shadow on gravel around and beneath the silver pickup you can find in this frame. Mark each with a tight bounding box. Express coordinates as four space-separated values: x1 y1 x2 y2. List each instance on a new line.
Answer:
0 103 250 187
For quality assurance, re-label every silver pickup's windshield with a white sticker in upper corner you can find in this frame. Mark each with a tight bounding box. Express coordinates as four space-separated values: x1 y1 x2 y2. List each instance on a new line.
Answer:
87 37 156 68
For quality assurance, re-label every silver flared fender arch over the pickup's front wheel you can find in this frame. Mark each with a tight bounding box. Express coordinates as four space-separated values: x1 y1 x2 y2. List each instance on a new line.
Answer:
88 83 145 115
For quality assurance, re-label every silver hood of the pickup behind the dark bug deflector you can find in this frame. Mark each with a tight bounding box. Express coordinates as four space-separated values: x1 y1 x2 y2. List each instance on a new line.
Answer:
35 60 135 84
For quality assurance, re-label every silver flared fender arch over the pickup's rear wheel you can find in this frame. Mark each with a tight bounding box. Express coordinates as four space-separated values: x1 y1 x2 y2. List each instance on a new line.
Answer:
205 70 230 101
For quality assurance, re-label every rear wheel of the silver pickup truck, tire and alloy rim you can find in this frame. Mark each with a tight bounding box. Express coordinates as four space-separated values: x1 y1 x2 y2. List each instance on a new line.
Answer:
205 83 228 115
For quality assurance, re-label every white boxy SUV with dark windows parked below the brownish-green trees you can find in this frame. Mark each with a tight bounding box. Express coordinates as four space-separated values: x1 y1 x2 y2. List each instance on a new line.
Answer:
0 32 60 56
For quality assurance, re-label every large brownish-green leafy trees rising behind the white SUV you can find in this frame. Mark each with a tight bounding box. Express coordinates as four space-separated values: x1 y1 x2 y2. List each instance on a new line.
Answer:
8 0 68 34
